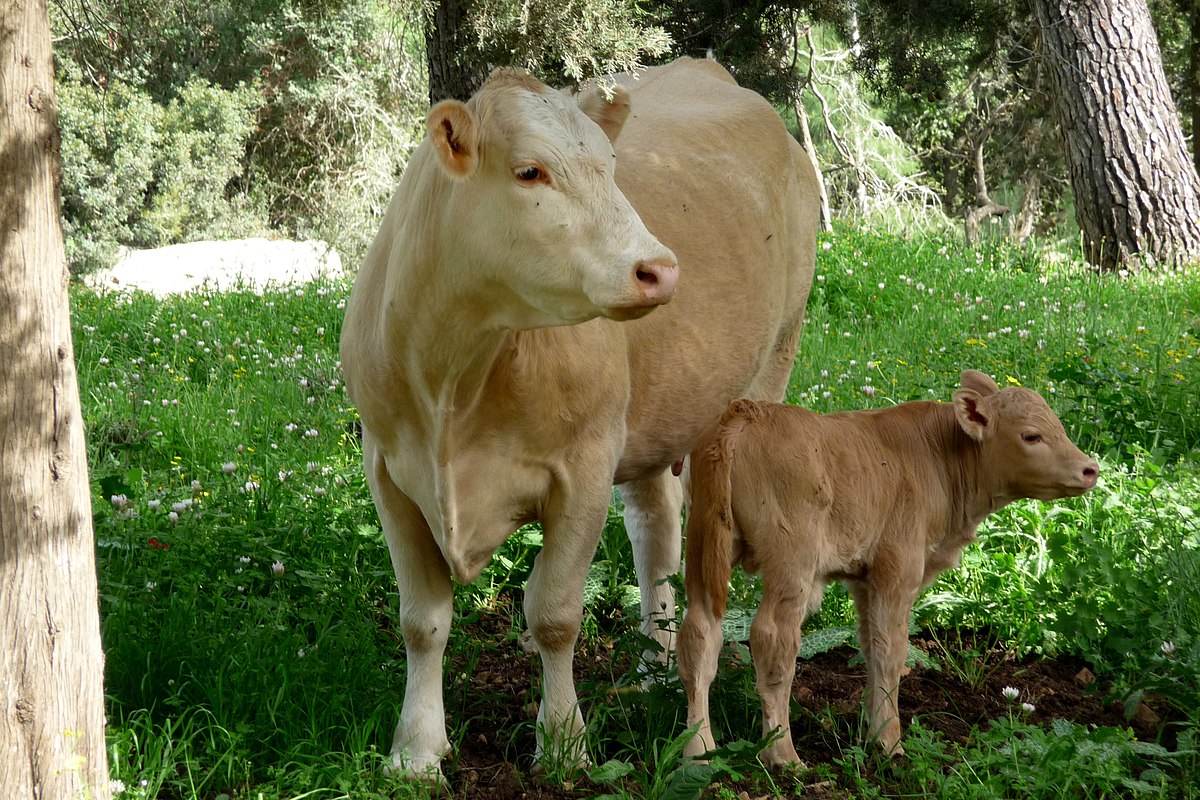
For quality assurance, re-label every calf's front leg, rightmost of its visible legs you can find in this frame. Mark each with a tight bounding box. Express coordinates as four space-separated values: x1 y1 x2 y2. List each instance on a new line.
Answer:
852 576 920 756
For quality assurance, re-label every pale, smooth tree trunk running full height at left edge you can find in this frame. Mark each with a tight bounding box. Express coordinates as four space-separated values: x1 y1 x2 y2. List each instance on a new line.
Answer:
0 0 109 800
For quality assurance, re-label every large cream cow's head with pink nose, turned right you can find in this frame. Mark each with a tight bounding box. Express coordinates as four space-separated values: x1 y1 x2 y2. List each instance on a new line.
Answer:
426 71 678 327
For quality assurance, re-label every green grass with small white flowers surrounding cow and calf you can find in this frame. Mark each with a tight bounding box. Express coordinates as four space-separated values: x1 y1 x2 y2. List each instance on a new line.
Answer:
73 230 1200 799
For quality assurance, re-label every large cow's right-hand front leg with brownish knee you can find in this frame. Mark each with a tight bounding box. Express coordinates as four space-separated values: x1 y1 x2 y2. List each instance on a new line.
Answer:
524 486 611 770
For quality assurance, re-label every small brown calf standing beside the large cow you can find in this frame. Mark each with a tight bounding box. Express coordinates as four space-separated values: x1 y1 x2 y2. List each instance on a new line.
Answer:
678 369 1098 764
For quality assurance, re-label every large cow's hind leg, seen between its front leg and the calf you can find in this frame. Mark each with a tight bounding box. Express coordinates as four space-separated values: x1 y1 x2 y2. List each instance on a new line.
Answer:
619 469 683 663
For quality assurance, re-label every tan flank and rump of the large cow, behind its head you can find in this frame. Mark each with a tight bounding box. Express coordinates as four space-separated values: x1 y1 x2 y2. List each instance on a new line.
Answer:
616 59 818 481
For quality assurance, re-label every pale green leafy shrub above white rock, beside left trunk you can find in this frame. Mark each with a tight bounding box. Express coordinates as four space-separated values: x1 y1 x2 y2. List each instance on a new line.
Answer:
56 65 262 275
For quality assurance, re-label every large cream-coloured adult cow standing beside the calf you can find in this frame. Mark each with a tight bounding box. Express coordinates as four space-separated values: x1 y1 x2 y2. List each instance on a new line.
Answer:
342 59 817 780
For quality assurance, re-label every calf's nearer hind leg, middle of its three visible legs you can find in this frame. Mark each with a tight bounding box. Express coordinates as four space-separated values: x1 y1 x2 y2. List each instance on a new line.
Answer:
750 576 811 765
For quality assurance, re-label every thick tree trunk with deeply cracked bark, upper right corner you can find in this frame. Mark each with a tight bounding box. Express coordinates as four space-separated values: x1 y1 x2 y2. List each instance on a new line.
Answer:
1034 0 1200 269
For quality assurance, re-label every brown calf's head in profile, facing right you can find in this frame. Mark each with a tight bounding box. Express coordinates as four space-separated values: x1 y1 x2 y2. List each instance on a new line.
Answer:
954 369 1099 500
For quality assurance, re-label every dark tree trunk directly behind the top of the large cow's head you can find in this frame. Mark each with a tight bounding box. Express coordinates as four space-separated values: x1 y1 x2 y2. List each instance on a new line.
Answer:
425 0 487 104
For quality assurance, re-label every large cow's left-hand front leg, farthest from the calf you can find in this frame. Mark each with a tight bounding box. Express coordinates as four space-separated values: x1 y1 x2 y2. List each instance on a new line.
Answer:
364 450 454 783
